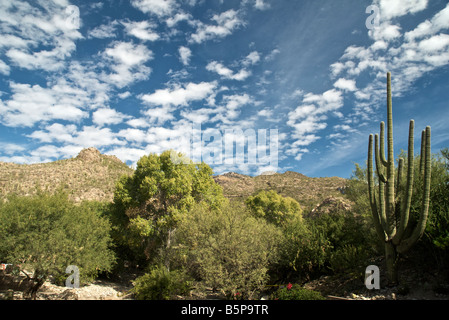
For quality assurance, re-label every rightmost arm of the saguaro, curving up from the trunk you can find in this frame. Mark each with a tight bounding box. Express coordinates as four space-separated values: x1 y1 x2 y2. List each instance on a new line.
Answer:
398 126 432 253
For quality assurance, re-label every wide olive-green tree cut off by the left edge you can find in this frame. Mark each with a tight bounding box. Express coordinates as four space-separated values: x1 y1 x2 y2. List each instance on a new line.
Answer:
0 192 115 299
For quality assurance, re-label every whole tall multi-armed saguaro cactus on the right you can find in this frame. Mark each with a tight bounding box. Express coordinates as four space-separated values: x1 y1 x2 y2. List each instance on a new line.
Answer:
368 73 431 285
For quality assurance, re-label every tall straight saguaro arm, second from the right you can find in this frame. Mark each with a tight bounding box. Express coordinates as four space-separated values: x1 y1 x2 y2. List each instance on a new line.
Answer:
393 120 415 244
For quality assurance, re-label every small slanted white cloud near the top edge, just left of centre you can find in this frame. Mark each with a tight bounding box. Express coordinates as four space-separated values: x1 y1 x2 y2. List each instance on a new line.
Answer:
190 9 244 43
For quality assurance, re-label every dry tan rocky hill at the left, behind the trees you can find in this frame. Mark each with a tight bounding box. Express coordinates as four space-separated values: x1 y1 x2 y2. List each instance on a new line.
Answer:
0 148 134 202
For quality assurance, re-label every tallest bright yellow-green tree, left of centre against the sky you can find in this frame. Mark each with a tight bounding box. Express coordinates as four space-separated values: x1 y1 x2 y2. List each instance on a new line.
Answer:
111 151 225 268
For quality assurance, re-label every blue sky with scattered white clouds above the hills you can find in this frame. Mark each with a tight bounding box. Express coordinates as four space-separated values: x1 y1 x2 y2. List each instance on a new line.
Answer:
0 0 449 177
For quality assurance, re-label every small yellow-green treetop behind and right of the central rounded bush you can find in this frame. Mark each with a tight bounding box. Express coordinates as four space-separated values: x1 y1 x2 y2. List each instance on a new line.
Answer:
245 190 302 226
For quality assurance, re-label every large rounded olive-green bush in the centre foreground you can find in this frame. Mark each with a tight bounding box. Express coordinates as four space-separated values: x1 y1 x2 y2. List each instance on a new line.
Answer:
176 203 281 299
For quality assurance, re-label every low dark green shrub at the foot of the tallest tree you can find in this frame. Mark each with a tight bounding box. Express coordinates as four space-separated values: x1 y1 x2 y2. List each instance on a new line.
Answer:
131 266 191 300
